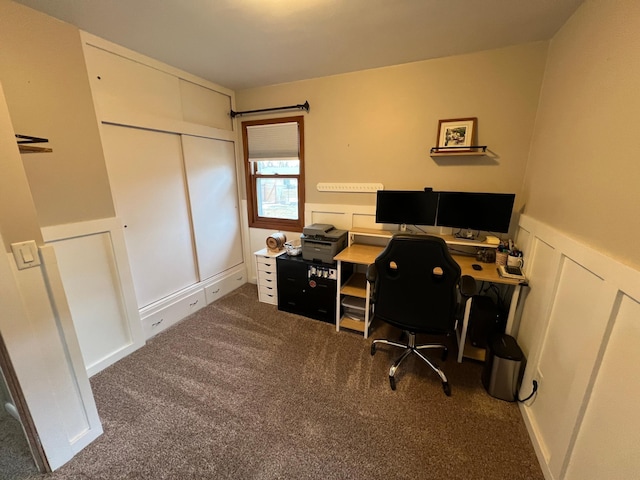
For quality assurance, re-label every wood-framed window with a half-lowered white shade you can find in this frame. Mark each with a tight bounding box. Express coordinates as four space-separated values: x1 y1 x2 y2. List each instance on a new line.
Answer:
242 116 304 232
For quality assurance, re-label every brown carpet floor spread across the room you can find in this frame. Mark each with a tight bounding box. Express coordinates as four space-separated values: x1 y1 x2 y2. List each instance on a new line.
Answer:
17 284 543 480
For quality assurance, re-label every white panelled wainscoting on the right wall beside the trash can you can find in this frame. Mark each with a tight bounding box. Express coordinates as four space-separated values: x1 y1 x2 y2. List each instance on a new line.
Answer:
516 215 640 480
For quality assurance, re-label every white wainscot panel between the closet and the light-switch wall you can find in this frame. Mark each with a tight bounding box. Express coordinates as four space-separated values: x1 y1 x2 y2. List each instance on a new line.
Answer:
42 218 144 376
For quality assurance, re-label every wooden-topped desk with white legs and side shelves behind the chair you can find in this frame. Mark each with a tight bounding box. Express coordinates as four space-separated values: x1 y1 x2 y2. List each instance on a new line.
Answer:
334 238 524 362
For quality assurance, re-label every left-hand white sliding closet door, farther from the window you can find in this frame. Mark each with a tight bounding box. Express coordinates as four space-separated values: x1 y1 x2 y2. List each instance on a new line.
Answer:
102 124 198 308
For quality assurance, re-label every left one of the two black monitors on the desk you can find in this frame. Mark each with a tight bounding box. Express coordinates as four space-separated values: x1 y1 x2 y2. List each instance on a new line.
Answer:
376 190 438 225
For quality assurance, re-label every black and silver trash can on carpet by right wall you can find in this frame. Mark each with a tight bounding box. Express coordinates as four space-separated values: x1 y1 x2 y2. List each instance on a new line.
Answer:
482 334 524 402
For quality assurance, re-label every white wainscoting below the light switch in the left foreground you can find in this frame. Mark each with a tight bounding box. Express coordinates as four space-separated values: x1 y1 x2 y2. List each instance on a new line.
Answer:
0 246 102 470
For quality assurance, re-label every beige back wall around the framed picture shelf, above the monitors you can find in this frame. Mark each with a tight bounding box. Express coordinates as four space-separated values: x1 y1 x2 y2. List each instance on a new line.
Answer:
236 42 548 215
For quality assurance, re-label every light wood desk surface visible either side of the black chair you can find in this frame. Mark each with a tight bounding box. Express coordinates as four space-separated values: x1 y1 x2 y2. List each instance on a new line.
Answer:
333 244 522 285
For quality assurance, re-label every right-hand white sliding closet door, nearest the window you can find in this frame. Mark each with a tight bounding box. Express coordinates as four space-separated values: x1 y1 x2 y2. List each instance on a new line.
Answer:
182 135 242 280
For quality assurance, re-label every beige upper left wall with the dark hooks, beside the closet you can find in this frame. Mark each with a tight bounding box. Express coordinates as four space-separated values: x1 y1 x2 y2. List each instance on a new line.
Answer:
0 0 114 226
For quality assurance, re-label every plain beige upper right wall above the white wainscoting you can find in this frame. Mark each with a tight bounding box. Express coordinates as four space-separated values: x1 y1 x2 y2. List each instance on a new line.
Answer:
526 0 640 268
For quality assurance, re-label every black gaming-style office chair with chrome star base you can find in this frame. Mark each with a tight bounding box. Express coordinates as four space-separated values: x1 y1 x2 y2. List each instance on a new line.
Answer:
367 234 475 396
